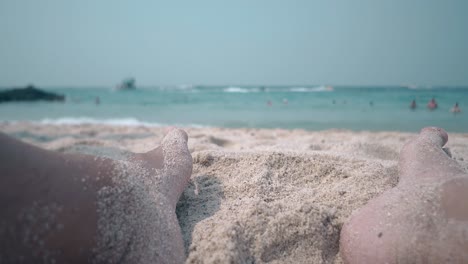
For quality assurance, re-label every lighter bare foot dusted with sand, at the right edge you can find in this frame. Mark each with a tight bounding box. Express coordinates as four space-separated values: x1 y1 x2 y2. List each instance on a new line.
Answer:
340 128 468 263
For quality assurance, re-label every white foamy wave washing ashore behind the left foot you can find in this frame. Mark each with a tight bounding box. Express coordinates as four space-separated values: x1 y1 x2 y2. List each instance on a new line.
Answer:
35 117 207 127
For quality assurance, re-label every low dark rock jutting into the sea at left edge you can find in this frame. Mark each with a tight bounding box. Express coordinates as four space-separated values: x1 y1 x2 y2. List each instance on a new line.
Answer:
0 85 65 103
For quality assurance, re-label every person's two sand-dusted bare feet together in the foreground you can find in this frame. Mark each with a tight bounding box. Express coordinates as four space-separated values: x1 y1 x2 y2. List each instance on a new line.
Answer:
0 128 468 263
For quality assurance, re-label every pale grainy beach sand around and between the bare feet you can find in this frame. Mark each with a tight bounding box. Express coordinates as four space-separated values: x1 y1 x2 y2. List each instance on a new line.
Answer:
0 123 468 263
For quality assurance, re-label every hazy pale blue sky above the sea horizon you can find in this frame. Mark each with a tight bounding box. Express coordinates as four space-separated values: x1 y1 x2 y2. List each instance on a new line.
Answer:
0 0 468 86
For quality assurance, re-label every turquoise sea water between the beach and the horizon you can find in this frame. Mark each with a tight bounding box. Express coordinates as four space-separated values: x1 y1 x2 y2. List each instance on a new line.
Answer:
0 86 468 132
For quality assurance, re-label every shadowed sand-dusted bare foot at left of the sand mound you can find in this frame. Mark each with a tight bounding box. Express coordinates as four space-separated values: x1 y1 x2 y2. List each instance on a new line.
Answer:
0 129 192 263
